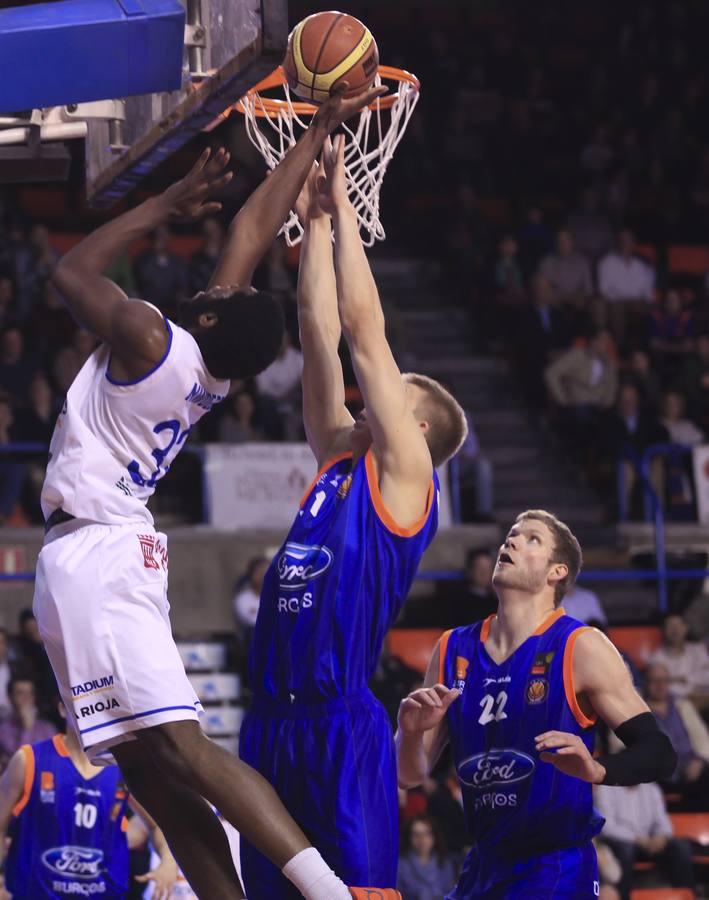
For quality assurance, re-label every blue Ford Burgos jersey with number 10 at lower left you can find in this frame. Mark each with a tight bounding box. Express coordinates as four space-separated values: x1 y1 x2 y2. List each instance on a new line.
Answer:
5 735 129 900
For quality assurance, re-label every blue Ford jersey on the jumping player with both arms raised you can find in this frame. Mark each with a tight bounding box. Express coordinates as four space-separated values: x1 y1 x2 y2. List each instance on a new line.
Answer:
250 449 438 704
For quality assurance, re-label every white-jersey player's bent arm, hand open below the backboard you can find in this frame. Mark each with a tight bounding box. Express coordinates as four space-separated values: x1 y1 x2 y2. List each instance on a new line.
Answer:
52 150 231 377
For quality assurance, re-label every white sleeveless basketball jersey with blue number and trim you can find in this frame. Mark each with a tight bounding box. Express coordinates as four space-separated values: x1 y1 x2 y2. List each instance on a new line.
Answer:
42 311 229 525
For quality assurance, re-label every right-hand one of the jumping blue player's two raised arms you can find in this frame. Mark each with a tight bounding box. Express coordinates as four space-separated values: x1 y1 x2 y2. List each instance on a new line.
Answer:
318 135 432 527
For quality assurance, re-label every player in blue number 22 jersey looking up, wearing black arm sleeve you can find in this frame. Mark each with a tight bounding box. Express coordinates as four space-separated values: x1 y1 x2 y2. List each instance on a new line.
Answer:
396 510 676 900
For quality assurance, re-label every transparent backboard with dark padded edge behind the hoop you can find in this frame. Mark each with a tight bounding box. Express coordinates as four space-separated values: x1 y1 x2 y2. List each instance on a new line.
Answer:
86 0 288 207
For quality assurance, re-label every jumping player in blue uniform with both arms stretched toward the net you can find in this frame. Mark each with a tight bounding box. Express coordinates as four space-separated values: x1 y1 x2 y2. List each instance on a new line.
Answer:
239 138 466 900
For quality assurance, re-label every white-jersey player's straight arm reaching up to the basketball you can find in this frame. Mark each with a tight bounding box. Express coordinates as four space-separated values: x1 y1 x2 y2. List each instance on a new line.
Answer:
209 82 386 288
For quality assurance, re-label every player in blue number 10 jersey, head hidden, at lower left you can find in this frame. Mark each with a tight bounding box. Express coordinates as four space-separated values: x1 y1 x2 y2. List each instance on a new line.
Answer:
0 712 178 900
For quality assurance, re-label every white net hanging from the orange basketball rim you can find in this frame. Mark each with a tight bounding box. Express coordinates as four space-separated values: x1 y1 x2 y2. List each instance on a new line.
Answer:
241 76 419 247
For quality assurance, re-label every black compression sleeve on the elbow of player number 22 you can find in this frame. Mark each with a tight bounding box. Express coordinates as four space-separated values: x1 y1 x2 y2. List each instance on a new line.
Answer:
598 712 677 785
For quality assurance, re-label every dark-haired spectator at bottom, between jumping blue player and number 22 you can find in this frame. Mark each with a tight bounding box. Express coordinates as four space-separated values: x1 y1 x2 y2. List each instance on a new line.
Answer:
396 816 457 900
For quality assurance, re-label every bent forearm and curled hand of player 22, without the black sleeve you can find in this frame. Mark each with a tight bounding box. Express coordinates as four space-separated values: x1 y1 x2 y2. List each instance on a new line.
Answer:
395 641 460 788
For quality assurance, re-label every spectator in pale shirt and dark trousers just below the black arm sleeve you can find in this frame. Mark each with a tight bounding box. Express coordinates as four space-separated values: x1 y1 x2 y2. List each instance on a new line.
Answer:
594 784 695 900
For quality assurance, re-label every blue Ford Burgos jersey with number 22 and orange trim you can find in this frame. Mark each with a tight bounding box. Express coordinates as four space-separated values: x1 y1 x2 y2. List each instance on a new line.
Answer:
440 609 603 898
